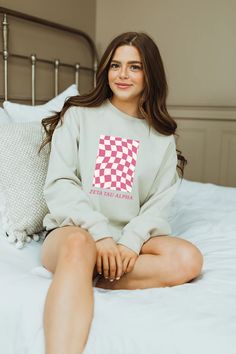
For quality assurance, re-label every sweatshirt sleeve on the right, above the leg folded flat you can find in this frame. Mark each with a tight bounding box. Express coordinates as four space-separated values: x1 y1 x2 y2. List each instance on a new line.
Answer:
117 136 180 254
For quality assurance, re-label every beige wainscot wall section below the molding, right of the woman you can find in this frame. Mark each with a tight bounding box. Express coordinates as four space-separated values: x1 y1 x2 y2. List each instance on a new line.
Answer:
169 107 236 187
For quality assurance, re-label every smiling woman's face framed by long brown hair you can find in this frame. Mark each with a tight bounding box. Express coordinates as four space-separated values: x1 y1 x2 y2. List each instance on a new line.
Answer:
108 45 145 105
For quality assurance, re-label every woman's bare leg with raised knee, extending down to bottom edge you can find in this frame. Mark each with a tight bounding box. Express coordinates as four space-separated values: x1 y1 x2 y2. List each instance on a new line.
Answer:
42 226 96 354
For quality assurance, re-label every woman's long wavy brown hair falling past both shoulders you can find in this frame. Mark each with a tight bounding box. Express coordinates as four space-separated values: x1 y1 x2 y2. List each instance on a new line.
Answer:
40 32 187 177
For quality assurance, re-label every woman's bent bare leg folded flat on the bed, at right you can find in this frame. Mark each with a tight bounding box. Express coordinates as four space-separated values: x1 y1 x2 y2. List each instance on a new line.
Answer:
96 236 203 290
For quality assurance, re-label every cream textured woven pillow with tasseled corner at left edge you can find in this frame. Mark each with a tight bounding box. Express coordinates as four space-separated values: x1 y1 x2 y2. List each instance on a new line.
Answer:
0 122 49 248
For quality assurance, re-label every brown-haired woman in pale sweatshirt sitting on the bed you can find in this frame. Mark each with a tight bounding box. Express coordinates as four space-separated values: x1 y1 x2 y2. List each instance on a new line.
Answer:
42 32 203 354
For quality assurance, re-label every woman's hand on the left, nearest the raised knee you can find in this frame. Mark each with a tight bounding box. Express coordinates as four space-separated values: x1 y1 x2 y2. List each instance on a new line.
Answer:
96 237 123 280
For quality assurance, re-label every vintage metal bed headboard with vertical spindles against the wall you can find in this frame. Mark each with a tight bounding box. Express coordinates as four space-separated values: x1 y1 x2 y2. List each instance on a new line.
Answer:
0 7 98 105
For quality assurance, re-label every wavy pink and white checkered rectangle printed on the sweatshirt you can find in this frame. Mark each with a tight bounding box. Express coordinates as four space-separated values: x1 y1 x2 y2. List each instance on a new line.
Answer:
93 135 139 192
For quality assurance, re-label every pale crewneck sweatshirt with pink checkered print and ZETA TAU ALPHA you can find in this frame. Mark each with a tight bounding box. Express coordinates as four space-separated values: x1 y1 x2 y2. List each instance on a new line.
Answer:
44 100 180 254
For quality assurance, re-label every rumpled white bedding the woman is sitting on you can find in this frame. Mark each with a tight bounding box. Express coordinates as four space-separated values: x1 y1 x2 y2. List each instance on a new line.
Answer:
0 180 236 354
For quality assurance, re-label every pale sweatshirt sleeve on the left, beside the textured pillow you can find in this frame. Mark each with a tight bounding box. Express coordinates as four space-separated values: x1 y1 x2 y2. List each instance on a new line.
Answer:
44 107 112 241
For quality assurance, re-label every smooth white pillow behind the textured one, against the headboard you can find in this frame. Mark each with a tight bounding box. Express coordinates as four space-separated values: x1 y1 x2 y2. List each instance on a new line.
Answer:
3 84 79 122
